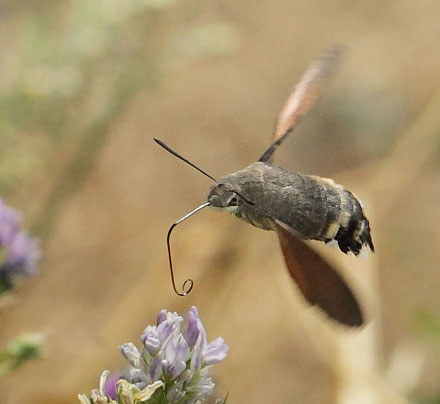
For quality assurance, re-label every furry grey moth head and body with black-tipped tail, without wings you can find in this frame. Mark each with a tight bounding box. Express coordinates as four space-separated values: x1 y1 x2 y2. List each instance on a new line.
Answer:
208 162 374 255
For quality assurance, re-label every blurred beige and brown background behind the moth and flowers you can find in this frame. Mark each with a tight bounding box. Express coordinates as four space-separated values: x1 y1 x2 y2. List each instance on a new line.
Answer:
0 0 440 404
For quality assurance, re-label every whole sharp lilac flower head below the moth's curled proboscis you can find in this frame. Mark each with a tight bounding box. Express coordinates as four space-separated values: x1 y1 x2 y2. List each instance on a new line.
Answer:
78 307 228 404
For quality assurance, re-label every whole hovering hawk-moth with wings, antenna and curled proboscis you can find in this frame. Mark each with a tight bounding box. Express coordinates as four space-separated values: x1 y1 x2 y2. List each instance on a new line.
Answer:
154 46 374 327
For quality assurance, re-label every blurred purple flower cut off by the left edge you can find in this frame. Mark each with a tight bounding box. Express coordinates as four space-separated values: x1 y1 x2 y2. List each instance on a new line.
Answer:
0 199 40 292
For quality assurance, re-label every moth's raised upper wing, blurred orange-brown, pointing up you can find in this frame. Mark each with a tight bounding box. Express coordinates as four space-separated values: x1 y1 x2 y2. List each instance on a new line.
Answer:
258 45 343 162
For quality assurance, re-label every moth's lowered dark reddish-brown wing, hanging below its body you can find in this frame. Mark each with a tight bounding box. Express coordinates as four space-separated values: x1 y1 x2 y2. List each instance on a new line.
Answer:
274 219 364 327
